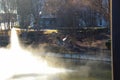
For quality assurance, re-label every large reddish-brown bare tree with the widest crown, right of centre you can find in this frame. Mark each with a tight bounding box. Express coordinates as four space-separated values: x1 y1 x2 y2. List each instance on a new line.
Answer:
57 0 110 33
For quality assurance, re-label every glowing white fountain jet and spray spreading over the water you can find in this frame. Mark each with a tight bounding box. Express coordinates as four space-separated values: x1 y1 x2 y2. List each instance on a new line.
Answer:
0 28 64 80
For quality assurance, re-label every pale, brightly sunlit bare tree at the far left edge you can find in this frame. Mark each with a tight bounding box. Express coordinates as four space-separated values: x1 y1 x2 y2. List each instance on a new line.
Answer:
1 0 16 29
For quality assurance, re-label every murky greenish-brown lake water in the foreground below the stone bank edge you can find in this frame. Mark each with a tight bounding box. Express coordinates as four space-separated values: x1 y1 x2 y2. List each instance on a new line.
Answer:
10 59 112 80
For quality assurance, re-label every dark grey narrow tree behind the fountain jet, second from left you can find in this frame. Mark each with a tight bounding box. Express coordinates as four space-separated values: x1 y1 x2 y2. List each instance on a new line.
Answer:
17 0 32 29
